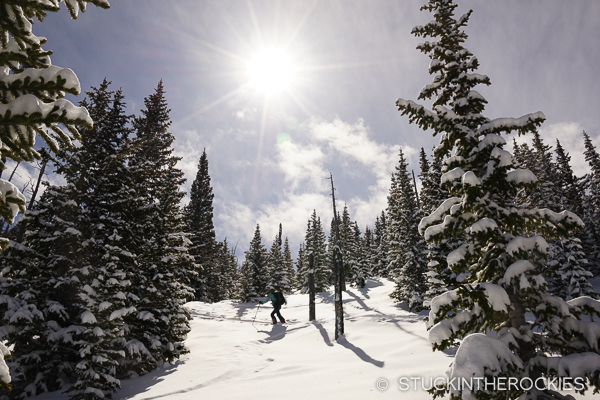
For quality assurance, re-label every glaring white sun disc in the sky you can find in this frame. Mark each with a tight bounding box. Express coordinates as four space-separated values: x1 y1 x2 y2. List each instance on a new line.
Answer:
249 49 294 94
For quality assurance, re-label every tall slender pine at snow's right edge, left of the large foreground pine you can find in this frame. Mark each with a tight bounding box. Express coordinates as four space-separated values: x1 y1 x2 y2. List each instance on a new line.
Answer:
386 149 427 311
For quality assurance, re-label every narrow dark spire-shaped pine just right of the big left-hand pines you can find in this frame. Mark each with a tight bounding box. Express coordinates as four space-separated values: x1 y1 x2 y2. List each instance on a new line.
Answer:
183 149 223 302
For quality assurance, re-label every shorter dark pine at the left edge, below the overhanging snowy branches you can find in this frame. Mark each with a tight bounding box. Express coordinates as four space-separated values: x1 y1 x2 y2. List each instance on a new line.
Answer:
0 186 82 398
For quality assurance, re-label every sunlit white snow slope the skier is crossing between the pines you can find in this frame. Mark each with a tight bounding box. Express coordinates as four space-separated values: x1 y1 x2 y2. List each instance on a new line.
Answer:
36 279 600 400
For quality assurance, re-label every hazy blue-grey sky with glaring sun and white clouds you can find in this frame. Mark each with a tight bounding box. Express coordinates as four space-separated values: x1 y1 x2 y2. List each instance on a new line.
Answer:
22 0 600 258
